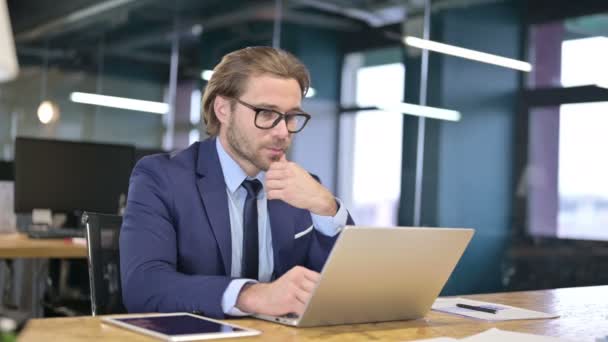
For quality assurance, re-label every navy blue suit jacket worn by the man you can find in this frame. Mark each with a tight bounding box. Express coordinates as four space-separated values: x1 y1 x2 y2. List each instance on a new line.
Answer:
120 138 352 318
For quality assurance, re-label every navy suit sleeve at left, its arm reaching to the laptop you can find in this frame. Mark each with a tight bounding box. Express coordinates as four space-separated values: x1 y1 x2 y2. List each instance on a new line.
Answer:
120 157 232 318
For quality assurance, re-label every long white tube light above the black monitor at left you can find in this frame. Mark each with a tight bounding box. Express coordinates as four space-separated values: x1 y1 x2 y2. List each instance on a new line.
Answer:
70 92 169 114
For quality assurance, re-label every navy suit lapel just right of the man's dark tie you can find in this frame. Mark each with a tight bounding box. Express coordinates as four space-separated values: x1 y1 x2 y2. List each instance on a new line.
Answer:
268 200 294 274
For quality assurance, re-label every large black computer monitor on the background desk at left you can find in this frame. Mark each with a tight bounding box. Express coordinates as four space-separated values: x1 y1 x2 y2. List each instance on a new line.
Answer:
14 137 135 214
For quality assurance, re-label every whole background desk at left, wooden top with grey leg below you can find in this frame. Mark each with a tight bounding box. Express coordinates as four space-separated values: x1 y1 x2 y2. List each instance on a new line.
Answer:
0 233 87 317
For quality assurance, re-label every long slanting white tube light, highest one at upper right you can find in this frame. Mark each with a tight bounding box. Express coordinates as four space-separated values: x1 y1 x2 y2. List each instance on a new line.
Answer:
403 36 532 72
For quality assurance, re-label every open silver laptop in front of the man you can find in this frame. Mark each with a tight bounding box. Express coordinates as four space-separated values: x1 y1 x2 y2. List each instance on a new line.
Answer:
254 226 474 327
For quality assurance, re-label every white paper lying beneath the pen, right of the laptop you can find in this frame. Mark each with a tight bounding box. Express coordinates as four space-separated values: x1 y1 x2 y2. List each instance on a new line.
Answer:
432 298 559 321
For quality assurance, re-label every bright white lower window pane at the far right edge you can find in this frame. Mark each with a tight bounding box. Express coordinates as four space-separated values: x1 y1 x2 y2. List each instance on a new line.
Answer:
557 102 608 240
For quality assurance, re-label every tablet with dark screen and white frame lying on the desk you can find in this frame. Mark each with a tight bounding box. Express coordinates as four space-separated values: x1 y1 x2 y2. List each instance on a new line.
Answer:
114 315 246 336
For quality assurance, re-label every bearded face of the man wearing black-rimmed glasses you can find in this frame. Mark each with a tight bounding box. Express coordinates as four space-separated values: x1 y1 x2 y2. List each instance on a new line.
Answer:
220 75 302 174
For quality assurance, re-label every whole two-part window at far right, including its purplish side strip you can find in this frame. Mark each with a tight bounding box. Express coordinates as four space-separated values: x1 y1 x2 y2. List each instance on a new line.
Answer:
526 25 608 241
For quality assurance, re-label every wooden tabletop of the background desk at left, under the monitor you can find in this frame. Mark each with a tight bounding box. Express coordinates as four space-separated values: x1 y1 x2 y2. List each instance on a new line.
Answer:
0 233 87 259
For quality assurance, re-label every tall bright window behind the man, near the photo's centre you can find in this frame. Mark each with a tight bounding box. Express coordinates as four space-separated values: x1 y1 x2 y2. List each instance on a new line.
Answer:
338 49 405 226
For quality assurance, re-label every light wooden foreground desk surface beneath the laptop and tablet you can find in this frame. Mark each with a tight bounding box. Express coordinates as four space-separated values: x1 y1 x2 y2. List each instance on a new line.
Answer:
19 286 608 342
